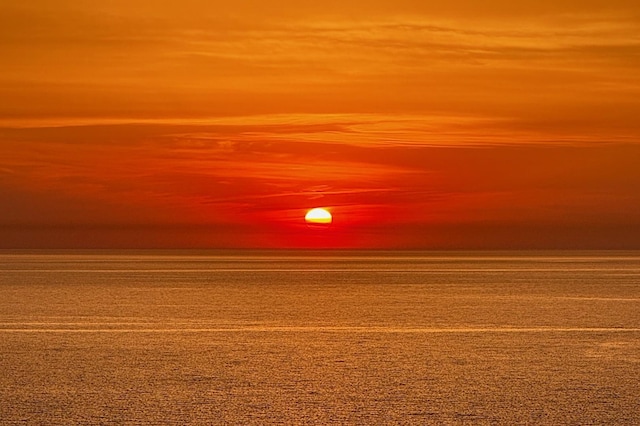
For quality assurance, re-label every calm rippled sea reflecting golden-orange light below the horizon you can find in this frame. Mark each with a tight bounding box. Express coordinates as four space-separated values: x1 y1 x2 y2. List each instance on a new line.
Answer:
0 251 640 425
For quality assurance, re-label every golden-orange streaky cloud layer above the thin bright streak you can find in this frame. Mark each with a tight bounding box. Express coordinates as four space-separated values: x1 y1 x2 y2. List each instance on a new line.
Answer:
0 1 640 123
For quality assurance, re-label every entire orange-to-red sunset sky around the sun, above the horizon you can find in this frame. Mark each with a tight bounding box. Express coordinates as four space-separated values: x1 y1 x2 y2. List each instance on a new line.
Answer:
0 0 640 249
